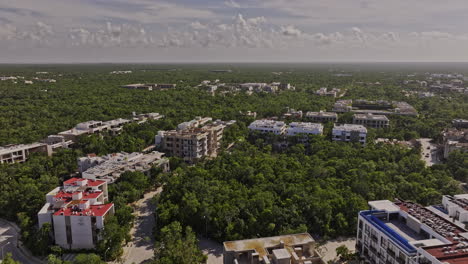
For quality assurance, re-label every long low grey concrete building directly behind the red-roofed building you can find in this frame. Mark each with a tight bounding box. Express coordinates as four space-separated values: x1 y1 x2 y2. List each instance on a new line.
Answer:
78 151 169 183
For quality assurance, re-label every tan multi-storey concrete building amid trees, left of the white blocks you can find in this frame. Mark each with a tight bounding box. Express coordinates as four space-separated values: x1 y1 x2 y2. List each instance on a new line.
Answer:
155 117 236 164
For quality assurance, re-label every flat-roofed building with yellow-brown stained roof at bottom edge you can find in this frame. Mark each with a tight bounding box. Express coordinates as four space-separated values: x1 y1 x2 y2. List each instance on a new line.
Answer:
223 233 325 264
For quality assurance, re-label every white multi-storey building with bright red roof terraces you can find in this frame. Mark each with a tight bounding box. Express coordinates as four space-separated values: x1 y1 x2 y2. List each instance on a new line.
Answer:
37 178 114 249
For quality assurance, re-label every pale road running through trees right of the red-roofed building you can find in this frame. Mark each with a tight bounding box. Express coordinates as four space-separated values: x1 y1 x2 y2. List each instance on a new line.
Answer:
114 188 162 264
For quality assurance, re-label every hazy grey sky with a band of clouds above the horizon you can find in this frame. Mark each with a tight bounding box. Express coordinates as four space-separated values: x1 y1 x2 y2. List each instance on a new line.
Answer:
0 0 468 63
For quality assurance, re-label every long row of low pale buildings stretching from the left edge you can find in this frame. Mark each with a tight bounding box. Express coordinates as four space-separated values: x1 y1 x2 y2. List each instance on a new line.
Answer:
0 113 164 164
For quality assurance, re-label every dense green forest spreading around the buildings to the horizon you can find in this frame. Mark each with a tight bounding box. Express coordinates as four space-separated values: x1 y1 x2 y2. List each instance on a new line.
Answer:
0 64 468 263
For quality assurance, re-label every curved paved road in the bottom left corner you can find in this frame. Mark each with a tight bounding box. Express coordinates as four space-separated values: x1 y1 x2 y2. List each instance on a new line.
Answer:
0 219 45 264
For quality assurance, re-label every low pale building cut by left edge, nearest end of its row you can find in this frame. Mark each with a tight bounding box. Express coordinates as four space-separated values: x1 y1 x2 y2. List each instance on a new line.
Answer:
0 143 47 164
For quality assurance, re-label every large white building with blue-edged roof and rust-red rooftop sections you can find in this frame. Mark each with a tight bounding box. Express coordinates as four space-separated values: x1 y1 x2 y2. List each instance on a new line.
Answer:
356 197 468 264
